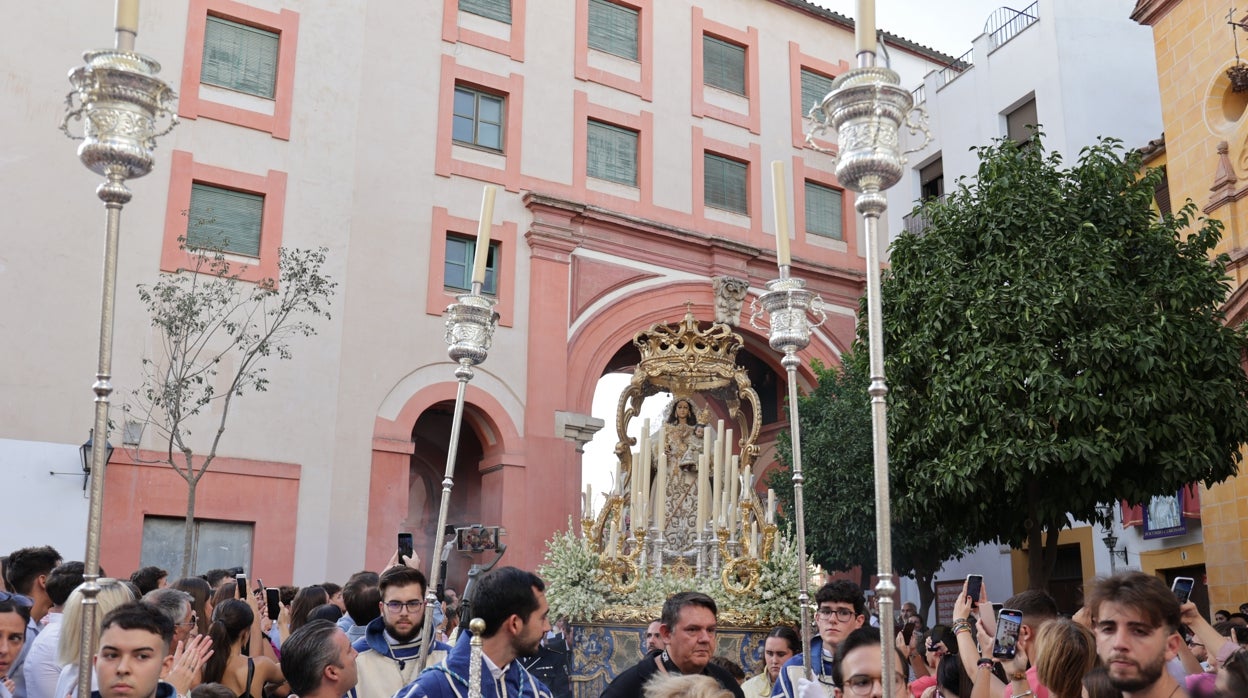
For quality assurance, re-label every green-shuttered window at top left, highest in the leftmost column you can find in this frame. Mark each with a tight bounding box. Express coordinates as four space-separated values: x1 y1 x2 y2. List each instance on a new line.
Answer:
200 15 278 100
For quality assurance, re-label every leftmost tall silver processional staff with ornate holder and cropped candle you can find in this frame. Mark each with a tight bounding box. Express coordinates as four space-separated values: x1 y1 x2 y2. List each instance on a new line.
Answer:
61 0 177 696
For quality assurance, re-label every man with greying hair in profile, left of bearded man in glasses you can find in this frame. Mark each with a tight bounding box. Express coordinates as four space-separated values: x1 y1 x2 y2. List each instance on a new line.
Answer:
282 621 357 698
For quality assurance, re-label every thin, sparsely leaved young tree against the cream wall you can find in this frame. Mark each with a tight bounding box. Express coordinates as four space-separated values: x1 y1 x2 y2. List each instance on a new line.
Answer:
125 247 337 577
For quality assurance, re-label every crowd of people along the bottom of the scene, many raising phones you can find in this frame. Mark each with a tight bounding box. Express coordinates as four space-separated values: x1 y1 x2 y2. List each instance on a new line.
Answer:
0 547 1248 698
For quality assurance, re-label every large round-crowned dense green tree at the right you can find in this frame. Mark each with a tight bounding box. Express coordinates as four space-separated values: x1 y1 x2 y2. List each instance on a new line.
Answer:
882 132 1248 588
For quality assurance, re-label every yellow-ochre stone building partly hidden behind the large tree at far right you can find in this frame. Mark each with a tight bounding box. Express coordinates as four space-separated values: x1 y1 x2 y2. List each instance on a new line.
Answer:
1131 0 1248 608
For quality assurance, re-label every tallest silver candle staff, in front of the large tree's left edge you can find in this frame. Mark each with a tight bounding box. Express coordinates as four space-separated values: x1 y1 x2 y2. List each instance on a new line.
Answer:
790 0 931 677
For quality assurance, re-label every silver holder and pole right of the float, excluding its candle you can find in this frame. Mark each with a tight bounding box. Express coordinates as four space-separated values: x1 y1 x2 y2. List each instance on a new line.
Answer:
750 270 827 676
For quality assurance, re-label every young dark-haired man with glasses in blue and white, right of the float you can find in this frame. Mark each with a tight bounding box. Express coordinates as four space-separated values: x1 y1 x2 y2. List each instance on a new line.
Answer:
771 579 866 698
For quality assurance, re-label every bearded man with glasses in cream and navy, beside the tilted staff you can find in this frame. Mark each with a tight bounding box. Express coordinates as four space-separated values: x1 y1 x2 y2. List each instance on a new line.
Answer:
354 564 451 698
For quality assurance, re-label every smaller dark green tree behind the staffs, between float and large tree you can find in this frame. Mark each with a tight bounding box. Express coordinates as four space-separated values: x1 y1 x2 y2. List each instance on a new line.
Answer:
769 347 968 618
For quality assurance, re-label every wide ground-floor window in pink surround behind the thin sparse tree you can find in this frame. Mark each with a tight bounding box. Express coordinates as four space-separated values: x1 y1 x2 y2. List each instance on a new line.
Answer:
139 516 256 574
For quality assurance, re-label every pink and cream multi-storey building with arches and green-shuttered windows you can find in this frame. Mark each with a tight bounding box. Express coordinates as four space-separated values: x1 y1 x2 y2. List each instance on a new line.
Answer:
0 0 948 583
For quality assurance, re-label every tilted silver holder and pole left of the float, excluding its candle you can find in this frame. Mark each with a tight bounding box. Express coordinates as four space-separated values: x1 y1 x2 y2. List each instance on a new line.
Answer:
416 287 498 671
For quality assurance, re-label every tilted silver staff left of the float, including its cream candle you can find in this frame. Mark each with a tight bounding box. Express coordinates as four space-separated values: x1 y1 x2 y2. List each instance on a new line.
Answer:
416 186 498 671
